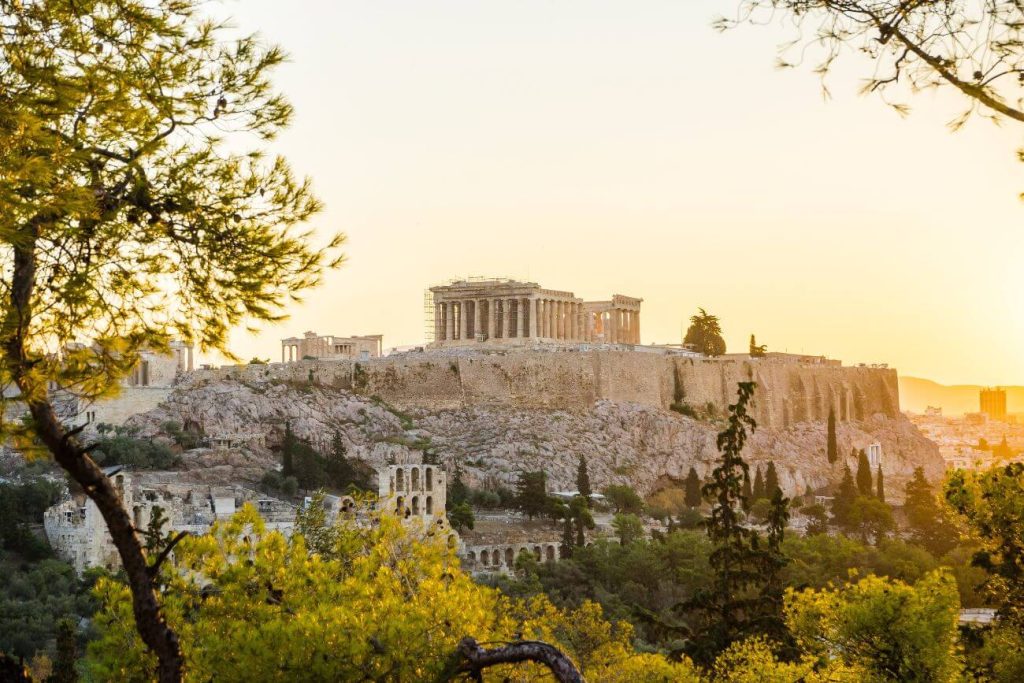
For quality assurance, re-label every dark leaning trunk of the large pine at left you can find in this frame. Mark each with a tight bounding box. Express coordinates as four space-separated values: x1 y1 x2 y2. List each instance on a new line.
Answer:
2 232 183 683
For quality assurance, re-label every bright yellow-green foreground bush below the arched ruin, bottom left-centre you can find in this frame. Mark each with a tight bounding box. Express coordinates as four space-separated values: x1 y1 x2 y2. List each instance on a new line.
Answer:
87 506 697 681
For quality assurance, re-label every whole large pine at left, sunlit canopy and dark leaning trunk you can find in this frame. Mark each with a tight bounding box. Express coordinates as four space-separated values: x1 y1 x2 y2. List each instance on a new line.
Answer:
0 0 342 681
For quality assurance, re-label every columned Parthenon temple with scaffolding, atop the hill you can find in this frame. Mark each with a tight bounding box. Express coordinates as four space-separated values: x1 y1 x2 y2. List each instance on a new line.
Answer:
430 279 643 346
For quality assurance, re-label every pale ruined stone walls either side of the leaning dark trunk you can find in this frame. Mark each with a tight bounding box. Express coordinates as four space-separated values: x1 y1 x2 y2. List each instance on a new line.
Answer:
43 465 295 574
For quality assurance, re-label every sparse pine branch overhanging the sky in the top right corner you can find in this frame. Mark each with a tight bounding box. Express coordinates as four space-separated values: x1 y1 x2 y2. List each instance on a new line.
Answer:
718 0 1024 137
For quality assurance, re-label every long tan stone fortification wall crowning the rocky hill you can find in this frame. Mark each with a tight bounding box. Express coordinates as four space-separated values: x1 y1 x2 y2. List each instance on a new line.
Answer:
188 350 899 428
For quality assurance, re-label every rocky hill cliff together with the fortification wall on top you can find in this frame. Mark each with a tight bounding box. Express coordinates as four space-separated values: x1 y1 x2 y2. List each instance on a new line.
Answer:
132 351 943 502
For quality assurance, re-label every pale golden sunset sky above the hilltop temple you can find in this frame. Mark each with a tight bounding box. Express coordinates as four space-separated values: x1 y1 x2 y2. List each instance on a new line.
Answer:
211 0 1024 384
